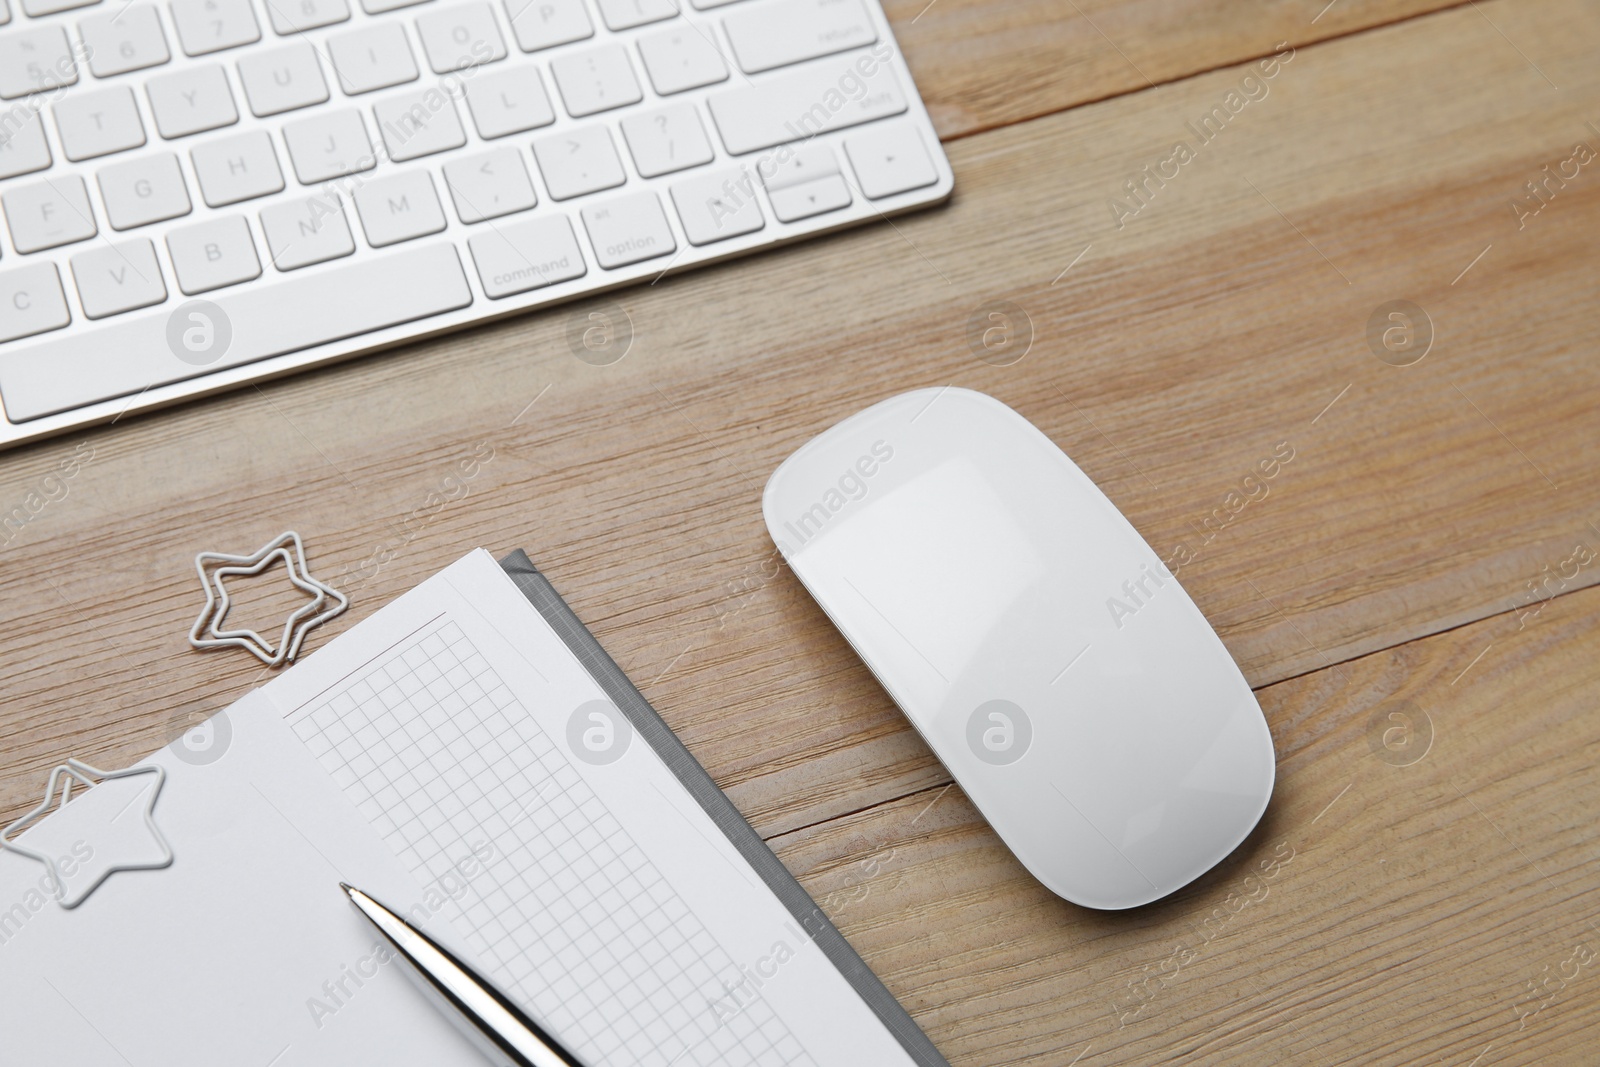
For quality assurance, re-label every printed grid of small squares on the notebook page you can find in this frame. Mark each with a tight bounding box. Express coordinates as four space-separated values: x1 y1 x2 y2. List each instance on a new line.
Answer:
291 617 814 1067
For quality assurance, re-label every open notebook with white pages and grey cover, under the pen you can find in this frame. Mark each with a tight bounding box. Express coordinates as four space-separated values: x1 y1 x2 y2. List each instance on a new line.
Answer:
0 550 946 1067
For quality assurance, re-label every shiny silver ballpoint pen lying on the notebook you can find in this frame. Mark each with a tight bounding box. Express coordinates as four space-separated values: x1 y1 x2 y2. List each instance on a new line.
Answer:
339 881 584 1067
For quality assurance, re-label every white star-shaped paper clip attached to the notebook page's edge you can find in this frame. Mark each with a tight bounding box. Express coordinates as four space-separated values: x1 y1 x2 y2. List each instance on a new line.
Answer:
0 760 173 909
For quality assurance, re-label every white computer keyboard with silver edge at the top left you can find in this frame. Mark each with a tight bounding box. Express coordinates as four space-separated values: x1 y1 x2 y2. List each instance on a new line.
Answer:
0 0 952 446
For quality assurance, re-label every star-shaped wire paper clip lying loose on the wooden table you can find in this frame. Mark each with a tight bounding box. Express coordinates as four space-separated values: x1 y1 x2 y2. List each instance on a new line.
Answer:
189 530 350 667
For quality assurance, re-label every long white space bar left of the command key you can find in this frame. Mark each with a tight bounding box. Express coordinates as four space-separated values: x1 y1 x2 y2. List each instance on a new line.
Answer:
0 242 472 422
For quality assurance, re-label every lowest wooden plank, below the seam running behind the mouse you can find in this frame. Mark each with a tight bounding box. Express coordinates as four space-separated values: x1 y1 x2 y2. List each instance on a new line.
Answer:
773 589 1600 1067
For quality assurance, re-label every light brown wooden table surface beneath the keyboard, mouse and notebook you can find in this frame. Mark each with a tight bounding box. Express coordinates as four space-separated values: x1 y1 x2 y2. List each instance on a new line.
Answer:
0 0 1600 1067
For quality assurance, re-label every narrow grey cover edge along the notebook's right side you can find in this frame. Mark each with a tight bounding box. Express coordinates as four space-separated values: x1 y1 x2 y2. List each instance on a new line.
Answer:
499 549 950 1067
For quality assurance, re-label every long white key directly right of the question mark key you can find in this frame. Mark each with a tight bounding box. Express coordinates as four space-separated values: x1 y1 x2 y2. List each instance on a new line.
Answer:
706 58 906 155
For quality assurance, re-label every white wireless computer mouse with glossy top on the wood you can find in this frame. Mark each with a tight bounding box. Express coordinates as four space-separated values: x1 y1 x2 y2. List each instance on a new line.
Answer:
762 389 1275 909
